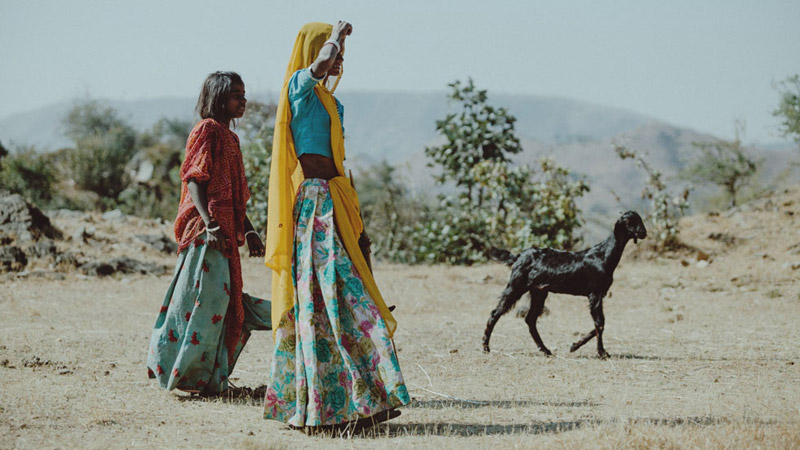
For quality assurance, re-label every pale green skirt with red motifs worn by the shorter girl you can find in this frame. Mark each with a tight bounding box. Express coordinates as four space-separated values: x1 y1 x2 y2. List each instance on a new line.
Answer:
147 235 272 393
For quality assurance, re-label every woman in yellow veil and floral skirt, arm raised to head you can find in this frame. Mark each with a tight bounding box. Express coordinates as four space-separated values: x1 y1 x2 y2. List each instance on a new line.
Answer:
264 21 410 429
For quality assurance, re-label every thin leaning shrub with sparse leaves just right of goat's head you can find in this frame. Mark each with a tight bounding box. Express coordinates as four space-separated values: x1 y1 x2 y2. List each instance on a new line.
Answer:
614 144 689 250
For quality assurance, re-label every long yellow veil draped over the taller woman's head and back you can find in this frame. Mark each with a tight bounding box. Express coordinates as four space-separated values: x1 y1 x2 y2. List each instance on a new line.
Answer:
265 22 397 337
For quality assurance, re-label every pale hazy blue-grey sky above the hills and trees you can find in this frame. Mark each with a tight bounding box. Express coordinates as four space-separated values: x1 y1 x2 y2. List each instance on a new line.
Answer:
0 0 800 142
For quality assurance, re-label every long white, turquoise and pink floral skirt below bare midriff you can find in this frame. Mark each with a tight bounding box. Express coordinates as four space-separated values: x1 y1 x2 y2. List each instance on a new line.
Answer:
264 178 410 427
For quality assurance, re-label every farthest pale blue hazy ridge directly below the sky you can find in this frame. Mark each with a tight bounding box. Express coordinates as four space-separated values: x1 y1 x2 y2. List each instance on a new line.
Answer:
0 91 653 156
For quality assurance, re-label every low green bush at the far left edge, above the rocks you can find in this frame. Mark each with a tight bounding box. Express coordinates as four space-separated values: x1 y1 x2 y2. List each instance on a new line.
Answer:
0 145 56 207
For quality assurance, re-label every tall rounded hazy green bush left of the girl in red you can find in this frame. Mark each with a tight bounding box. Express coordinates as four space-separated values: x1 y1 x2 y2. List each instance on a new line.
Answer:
65 100 136 204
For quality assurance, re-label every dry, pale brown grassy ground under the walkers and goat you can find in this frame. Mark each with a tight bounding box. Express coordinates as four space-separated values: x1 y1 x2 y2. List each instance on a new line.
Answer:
0 189 800 448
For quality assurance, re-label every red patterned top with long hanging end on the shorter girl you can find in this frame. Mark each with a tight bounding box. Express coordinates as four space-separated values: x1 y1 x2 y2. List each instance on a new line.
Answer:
175 119 250 364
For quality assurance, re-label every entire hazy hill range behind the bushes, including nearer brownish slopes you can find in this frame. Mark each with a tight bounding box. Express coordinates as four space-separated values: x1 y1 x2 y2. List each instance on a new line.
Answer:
0 91 800 243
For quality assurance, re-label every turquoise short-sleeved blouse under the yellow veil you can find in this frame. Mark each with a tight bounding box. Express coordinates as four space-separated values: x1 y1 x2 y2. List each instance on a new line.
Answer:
289 68 344 158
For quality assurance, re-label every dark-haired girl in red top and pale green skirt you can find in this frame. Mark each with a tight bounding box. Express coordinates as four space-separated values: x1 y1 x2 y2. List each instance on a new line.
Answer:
147 72 272 394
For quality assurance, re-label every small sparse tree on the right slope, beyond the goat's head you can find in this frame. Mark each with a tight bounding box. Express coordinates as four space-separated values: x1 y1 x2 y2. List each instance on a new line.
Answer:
684 126 762 208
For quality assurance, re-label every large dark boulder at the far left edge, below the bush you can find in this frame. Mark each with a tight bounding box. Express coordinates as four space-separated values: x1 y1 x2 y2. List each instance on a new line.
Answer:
0 194 62 241
